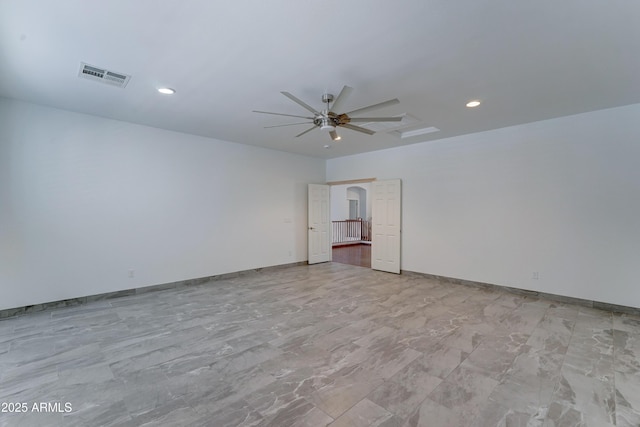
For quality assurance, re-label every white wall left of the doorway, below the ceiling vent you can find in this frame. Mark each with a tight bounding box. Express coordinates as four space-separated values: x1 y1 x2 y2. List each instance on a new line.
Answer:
0 98 325 309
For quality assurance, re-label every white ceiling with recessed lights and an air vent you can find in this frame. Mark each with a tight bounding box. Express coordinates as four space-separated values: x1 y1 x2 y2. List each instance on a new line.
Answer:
0 0 640 158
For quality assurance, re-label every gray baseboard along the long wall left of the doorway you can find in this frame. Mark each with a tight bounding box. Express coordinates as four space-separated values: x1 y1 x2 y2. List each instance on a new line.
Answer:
0 261 307 320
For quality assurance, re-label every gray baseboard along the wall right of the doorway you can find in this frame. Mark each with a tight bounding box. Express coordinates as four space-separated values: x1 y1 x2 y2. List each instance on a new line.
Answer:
402 270 640 316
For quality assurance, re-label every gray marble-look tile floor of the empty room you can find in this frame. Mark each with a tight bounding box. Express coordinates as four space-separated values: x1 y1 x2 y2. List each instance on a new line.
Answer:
0 263 640 427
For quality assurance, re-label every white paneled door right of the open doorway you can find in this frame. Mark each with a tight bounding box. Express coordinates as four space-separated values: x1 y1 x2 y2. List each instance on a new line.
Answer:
371 179 401 274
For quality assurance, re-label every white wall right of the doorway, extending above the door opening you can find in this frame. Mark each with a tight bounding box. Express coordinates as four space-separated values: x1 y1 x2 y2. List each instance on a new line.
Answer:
327 104 640 307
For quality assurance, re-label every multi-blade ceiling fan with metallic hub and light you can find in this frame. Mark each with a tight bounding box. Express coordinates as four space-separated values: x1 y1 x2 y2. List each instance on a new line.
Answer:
253 86 402 141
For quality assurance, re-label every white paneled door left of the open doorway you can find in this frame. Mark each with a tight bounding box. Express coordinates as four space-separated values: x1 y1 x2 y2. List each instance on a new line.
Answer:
308 184 331 264
